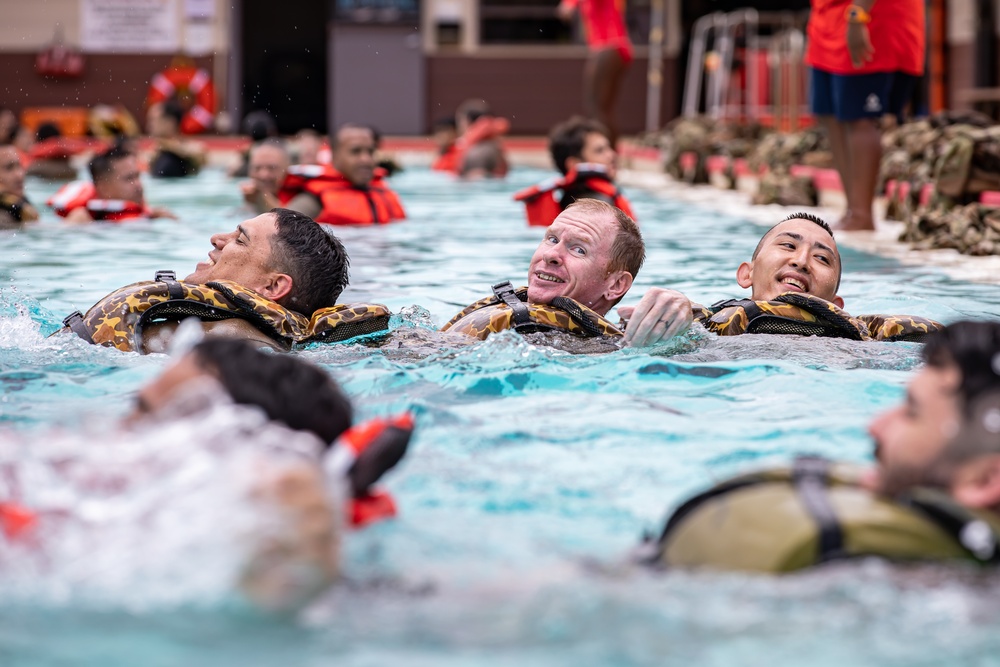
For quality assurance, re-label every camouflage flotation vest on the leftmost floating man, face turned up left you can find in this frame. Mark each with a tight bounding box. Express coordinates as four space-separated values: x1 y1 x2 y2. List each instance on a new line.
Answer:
61 271 390 352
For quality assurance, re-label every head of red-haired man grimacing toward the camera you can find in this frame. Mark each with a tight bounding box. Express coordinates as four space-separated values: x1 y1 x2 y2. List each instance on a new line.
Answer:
528 199 646 315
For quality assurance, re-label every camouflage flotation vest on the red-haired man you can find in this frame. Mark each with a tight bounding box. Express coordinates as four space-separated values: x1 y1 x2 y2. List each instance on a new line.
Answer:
441 281 622 340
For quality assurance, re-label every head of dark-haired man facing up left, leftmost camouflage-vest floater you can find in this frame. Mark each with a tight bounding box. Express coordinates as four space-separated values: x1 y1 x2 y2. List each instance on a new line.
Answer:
184 208 349 317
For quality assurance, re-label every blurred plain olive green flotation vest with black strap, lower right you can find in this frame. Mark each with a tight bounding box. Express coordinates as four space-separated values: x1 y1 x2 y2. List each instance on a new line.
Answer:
640 457 1000 573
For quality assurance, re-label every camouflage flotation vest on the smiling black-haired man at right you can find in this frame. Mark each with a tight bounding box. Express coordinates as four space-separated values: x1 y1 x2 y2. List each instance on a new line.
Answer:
694 292 942 342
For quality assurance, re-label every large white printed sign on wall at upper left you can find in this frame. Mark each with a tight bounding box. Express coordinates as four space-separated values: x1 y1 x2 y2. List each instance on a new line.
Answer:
80 0 180 53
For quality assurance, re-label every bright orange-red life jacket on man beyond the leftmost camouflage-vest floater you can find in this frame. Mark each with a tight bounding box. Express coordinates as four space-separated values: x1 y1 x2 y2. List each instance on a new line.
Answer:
279 164 406 225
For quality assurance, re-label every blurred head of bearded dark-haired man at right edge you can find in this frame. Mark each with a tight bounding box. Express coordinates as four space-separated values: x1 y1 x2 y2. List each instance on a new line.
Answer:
866 321 1000 511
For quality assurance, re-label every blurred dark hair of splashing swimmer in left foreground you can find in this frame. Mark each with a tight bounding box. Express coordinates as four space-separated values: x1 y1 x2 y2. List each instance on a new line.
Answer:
192 338 352 447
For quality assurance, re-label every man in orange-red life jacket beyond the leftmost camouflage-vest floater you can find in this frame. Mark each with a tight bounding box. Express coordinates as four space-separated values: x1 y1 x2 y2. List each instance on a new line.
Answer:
285 124 406 225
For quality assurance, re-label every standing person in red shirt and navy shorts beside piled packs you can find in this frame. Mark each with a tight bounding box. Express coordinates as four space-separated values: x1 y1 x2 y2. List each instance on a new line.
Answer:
806 0 926 230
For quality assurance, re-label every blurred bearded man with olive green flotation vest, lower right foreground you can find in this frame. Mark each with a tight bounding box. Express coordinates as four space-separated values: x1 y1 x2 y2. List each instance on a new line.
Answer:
638 321 1000 572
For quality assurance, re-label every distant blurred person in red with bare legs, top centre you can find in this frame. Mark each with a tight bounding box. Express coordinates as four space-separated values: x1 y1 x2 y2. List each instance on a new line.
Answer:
558 0 632 148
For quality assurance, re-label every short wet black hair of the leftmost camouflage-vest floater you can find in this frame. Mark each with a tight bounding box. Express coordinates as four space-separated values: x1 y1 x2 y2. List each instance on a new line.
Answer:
269 208 350 317
